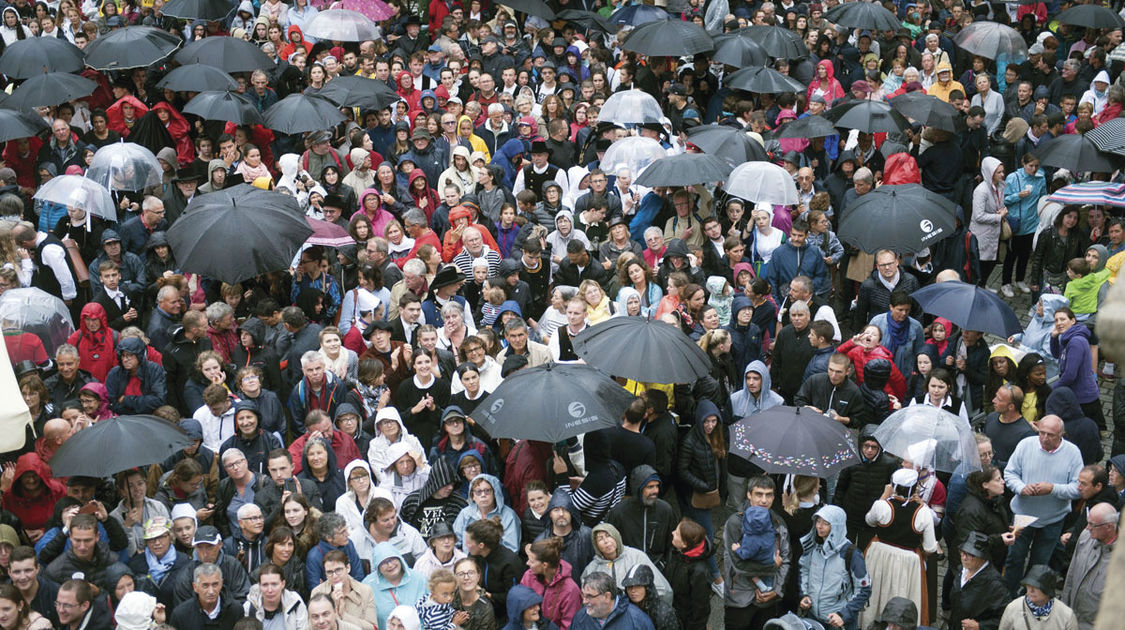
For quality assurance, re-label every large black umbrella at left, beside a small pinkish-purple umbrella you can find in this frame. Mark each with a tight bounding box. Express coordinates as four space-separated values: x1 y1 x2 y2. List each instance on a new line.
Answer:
168 183 313 280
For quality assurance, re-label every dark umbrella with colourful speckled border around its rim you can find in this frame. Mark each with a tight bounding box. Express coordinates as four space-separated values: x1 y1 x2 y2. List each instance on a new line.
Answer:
730 406 860 478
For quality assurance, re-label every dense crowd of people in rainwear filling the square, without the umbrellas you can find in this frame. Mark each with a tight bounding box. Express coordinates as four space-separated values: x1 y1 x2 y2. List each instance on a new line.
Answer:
0 0 1125 630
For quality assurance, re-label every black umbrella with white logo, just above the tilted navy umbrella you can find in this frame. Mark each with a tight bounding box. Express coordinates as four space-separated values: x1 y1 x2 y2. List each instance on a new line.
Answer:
838 183 957 253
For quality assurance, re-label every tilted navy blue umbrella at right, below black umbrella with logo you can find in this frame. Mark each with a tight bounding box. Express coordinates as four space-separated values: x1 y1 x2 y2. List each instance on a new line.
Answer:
910 281 1023 338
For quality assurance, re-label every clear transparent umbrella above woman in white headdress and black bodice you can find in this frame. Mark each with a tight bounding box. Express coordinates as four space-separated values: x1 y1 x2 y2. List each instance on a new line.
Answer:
874 405 981 474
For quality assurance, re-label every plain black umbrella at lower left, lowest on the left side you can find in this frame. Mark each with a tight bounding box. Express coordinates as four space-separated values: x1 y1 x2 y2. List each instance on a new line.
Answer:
50 415 194 478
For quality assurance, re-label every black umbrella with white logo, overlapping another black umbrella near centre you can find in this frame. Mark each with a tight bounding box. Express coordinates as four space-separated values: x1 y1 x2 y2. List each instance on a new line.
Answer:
473 364 635 443
